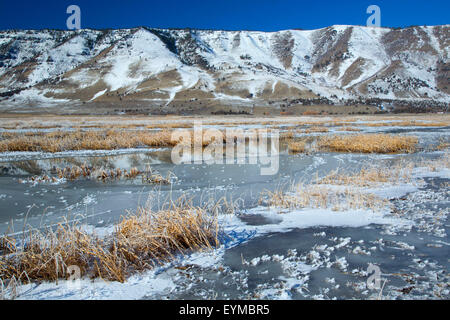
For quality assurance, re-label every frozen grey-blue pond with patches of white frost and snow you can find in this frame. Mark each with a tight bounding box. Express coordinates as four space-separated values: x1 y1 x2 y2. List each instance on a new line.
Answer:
0 128 450 299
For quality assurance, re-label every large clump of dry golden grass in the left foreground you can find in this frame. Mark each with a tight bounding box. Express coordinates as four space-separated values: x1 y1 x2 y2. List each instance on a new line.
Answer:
0 203 219 283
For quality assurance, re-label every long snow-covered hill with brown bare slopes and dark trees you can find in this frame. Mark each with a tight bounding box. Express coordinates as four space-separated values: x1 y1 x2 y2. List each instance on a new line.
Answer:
0 25 450 108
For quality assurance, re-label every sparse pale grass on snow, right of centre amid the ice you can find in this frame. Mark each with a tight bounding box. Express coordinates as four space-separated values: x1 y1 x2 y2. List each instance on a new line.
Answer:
259 153 450 213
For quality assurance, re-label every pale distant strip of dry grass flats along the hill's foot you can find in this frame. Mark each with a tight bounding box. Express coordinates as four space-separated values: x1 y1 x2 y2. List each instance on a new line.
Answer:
0 112 450 129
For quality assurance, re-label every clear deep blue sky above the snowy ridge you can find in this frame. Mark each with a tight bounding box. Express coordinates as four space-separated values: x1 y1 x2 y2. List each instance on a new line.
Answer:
0 0 450 31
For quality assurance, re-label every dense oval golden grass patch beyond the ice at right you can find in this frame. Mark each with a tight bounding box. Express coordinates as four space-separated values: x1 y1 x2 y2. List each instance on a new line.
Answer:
317 134 418 153
